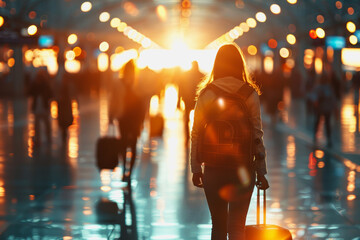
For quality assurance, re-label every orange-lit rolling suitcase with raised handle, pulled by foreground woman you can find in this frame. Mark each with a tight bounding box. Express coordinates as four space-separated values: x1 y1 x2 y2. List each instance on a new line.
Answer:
245 189 292 240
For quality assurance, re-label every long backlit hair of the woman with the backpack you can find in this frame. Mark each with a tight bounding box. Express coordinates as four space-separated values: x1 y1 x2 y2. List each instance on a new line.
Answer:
196 43 261 98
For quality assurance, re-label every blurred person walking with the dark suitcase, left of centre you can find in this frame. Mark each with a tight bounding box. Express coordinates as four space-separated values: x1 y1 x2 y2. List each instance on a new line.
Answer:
118 60 146 181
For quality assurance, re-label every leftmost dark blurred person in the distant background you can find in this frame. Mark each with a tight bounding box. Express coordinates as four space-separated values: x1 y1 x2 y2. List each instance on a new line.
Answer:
29 68 53 146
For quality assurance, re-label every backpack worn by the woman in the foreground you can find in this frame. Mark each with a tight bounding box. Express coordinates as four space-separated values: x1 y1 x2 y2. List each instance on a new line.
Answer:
199 84 254 169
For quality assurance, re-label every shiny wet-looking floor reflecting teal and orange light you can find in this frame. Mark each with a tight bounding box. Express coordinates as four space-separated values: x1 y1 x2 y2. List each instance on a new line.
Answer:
0 87 360 240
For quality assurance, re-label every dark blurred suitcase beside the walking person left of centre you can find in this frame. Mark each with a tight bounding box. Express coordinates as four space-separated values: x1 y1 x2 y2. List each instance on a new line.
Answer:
96 136 121 171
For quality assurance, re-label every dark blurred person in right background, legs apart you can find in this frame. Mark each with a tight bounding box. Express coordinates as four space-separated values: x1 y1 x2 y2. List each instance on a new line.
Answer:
314 73 337 147
